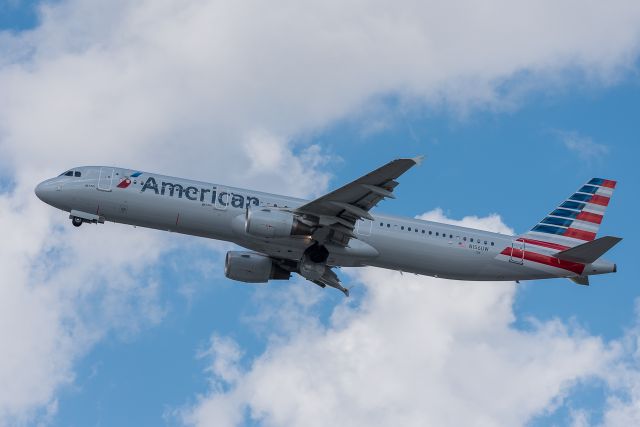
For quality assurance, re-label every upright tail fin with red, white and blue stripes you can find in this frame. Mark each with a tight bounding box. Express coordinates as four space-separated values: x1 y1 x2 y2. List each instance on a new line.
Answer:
520 178 616 250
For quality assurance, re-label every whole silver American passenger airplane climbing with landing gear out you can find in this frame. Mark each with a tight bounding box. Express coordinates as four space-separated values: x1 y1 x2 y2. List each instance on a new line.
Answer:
35 157 622 296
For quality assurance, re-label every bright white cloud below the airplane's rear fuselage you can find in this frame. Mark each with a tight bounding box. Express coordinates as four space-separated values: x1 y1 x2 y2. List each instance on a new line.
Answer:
180 211 618 426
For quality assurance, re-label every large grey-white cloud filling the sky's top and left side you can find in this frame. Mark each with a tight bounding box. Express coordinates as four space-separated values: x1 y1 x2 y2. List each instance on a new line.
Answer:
0 0 640 422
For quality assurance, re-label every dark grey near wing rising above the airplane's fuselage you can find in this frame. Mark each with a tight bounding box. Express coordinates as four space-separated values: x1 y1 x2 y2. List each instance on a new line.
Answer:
295 156 424 245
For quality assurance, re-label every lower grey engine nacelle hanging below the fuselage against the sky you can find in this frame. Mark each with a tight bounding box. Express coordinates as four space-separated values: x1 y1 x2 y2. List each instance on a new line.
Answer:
224 251 291 283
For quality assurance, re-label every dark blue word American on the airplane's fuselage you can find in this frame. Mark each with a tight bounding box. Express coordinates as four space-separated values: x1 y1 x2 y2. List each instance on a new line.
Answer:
140 175 260 209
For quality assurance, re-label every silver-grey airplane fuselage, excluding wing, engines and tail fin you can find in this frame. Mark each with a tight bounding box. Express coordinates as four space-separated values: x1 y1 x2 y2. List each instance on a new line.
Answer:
36 167 615 281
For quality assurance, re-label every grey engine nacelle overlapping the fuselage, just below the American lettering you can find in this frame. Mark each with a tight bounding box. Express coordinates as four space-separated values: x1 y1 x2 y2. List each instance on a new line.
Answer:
244 207 313 237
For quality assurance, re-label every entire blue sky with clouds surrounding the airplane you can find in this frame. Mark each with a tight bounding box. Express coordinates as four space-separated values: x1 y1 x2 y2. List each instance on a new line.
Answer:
0 0 640 426
